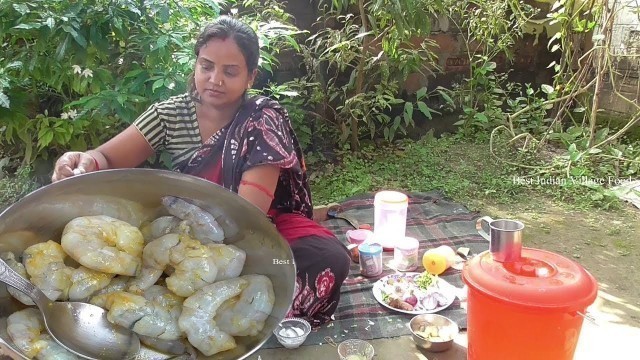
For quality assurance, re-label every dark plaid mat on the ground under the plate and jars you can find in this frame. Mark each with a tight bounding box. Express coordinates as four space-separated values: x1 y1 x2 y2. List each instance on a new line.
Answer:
263 192 489 349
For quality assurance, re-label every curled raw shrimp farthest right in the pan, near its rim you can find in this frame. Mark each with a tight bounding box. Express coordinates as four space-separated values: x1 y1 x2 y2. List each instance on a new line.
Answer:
214 275 275 336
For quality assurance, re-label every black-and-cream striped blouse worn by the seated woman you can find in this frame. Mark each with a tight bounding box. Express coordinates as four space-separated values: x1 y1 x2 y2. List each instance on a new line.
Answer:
133 93 202 169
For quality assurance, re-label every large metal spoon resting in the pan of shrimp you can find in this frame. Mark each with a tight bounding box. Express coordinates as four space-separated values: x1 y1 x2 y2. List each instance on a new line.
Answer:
0 260 140 360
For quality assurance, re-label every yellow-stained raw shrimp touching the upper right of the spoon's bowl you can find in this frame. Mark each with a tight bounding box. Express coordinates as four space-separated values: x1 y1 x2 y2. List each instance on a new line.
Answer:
105 285 184 340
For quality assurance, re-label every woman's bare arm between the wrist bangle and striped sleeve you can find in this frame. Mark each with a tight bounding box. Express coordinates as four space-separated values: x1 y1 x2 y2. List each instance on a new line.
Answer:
88 125 154 170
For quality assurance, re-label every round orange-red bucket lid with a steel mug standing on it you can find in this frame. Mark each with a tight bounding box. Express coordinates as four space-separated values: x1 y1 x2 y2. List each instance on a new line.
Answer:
462 247 598 311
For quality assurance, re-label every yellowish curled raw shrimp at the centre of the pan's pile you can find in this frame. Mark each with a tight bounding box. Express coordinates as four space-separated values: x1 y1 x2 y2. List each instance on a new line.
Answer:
129 234 218 297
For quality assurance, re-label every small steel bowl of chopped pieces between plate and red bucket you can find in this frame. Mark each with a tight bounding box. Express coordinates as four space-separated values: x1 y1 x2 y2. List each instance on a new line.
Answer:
409 314 460 352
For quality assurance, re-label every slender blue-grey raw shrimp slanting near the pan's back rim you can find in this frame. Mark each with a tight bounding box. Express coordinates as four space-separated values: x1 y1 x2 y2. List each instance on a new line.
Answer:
162 196 225 244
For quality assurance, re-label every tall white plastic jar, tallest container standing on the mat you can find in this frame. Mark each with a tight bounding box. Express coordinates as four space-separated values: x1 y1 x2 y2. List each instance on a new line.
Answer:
373 190 409 250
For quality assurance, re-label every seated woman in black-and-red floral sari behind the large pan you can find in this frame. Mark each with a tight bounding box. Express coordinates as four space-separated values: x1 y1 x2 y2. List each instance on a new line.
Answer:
52 17 350 327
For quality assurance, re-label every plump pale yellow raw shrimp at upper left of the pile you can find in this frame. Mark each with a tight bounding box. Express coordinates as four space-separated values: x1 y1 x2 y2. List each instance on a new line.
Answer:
61 215 144 276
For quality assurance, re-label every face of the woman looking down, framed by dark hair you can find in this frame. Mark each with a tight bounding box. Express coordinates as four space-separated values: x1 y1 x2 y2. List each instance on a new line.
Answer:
195 38 256 107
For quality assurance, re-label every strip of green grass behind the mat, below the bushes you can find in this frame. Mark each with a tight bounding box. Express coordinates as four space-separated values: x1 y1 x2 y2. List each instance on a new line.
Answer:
308 132 620 210
